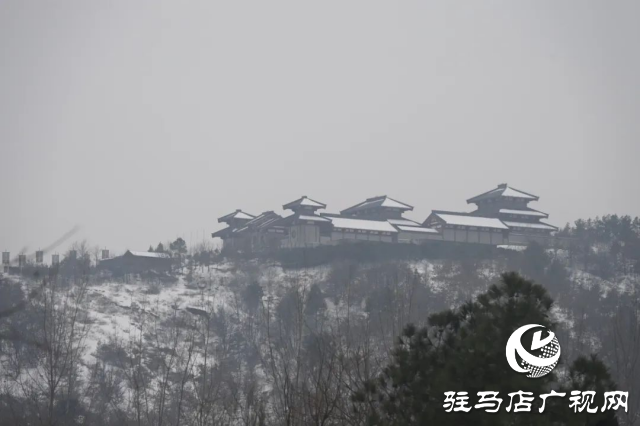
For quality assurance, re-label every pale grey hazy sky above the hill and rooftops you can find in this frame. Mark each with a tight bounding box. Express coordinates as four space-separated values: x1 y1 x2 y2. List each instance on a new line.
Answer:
0 0 640 253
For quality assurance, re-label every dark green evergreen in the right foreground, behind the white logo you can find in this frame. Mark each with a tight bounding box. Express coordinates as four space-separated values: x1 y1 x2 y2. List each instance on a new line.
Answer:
353 273 617 426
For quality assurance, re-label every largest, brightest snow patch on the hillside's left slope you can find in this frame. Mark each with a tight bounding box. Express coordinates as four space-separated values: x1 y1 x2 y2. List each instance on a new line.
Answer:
79 262 330 365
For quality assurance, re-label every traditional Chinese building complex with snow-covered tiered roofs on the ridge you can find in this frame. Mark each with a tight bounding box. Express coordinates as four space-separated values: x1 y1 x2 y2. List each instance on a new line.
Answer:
212 184 557 251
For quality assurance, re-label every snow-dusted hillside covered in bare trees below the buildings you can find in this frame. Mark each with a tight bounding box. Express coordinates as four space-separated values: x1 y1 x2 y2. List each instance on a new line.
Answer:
0 215 640 425
